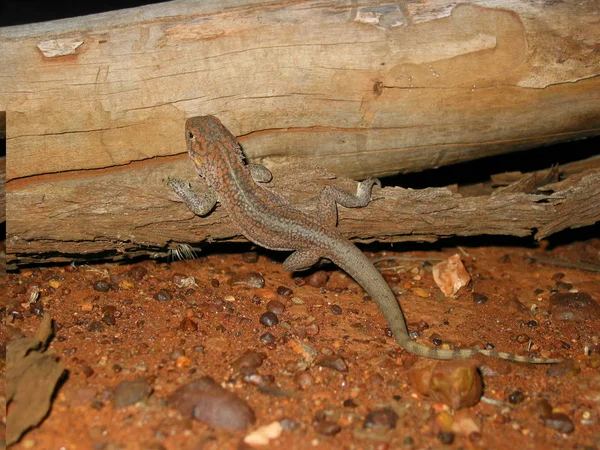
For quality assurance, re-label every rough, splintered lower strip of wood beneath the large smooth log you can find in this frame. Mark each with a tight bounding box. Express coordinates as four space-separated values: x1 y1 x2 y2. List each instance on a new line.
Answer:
7 160 600 263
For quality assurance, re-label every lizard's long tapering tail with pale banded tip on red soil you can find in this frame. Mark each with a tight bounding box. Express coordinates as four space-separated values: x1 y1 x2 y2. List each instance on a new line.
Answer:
327 242 561 364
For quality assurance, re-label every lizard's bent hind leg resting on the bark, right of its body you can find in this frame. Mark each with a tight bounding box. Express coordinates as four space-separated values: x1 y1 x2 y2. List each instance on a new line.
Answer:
319 178 381 228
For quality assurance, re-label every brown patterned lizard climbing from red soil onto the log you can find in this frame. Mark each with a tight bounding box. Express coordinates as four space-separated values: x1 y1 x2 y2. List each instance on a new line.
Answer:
167 116 560 363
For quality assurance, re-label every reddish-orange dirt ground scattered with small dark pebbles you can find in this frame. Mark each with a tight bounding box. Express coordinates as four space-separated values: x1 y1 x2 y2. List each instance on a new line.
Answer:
6 238 600 450
